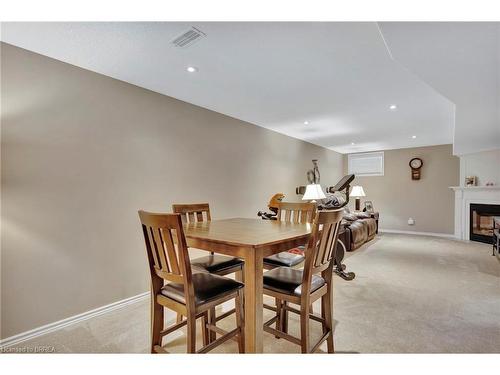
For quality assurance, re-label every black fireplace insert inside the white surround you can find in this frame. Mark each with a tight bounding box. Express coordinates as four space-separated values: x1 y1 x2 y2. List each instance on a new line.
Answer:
469 203 500 244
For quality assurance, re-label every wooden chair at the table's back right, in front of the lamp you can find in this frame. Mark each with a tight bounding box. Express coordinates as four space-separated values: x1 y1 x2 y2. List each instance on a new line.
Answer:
264 202 316 270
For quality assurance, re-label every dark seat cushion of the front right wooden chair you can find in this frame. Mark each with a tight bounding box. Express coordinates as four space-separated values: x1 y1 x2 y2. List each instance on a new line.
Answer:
264 267 325 296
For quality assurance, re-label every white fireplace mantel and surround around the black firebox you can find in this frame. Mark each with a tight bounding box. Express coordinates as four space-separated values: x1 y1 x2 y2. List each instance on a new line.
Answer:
450 185 500 240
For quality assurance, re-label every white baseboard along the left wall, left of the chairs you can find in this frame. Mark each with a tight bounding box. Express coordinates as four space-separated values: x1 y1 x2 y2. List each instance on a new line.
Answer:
0 291 150 349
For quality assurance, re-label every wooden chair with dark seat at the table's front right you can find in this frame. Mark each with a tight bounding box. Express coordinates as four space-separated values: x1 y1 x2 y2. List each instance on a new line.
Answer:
264 210 342 353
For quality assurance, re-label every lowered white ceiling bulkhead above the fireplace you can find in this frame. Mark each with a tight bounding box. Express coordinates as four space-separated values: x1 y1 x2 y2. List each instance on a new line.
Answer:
380 22 500 154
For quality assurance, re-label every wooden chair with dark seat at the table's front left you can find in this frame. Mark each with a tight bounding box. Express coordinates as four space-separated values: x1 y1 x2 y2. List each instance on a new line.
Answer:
139 211 244 353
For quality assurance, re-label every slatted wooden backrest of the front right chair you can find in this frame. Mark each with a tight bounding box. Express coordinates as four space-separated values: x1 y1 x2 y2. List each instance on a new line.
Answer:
303 209 343 284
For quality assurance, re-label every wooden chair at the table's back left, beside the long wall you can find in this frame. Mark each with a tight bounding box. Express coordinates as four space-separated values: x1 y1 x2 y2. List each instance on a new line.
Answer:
172 203 245 341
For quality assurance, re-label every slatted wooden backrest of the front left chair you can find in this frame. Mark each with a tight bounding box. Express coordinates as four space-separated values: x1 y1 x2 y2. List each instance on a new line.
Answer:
139 211 192 288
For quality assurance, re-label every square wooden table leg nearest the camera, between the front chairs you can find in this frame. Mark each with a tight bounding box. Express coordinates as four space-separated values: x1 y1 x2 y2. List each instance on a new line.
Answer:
244 249 264 353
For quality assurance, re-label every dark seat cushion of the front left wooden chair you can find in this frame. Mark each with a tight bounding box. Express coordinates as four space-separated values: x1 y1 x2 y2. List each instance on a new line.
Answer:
160 272 243 305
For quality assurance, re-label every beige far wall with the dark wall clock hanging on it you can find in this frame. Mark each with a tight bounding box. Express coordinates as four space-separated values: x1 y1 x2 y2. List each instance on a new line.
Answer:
344 145 460 234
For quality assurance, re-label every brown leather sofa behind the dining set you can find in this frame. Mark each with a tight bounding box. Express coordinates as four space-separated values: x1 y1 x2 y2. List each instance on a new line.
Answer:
339 209 379 251
